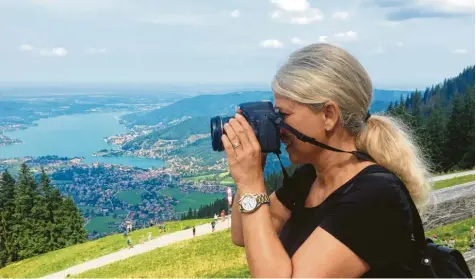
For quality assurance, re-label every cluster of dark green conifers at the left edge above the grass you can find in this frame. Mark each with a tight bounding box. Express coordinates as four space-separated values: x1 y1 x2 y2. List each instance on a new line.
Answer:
0 164 87 267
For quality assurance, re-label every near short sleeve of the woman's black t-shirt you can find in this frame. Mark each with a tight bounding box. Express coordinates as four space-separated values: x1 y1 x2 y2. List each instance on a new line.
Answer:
319 176 412 269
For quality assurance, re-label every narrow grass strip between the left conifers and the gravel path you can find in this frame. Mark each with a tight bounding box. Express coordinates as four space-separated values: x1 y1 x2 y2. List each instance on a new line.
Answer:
0 219 212 278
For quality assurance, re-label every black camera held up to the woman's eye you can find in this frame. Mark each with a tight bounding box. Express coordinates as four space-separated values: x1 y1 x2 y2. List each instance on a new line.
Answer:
210 101 281 153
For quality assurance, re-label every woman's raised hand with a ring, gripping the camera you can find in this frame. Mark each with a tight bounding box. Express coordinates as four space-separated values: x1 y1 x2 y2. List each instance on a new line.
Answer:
221 114 266 193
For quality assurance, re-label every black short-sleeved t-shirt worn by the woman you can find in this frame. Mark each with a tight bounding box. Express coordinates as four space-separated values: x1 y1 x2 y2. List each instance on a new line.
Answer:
280 165 412 278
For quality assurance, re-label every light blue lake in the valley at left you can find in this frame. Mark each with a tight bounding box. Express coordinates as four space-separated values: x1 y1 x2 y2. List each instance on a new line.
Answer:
0 112 165 168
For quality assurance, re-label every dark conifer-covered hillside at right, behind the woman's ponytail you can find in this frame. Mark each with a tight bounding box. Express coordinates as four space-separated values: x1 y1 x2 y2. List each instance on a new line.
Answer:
387 66 475 171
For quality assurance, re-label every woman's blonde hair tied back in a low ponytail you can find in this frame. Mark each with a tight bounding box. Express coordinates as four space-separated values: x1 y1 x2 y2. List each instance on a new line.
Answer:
272 44 432 213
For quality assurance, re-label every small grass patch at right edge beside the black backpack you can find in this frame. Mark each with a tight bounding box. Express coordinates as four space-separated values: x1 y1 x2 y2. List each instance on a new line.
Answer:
425 217 474 253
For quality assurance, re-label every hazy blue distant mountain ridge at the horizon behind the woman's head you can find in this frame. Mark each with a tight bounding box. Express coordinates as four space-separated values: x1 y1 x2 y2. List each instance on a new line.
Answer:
123 89 410 127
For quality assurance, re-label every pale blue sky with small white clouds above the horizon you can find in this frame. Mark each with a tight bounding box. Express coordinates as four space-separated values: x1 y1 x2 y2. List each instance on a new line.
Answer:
0 0 475 90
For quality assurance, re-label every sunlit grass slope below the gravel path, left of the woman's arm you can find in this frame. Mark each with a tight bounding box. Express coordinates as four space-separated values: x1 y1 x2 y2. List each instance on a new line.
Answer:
71 229 250 278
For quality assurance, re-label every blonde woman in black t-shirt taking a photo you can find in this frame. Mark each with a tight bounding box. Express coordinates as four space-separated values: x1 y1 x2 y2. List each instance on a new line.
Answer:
222 44 431 277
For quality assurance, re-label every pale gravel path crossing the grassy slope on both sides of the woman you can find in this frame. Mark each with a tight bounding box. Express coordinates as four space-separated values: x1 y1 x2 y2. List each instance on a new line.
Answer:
42 170 475 278
